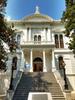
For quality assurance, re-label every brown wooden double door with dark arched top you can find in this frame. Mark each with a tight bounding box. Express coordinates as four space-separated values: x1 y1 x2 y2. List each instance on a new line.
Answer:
33 57 43 72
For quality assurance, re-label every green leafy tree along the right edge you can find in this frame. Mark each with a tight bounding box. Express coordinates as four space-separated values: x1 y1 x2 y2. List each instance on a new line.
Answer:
62 0 75 54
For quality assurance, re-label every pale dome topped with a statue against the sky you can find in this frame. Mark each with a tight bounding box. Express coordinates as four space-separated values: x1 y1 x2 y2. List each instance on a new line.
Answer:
23 7 53 22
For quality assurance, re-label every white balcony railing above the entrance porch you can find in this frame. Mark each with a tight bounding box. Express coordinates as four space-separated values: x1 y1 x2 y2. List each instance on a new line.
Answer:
21 41 55 47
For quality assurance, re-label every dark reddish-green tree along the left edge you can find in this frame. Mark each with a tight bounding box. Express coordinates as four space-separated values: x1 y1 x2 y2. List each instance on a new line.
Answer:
0 0 15 70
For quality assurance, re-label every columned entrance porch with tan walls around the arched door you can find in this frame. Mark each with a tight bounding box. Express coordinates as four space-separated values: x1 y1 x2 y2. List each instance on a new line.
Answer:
24 48 52 72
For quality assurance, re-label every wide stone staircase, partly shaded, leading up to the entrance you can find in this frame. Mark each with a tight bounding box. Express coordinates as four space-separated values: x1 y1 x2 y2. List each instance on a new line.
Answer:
13 71 65 100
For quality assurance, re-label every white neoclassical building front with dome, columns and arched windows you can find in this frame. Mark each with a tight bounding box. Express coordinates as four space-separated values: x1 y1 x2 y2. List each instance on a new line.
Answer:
7 7 75 89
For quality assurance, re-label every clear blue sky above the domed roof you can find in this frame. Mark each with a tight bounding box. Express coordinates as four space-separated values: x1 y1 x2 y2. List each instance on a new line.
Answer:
6 0 65 20
